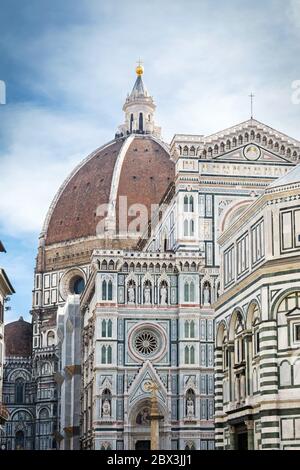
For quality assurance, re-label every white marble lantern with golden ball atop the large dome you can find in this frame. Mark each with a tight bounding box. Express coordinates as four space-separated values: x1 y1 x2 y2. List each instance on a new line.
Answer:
117 62 161 138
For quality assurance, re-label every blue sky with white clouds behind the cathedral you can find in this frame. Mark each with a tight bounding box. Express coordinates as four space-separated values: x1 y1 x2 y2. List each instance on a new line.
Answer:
0 0 300 322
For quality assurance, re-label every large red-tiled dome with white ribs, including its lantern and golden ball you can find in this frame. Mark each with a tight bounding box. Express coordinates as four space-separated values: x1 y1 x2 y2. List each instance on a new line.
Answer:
37 65 175 264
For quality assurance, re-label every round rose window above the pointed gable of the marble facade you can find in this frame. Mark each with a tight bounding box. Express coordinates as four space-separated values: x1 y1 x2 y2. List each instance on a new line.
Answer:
128 323 168 361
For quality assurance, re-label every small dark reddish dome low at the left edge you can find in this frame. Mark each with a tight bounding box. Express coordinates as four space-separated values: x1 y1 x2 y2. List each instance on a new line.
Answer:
4 317 32 357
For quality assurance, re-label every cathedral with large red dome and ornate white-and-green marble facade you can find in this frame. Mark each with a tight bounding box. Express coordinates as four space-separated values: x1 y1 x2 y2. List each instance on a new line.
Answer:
3 66 300 450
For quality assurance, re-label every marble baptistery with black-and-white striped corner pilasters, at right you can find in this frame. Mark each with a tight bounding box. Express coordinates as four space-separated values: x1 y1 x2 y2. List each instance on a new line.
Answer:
215 165 300 450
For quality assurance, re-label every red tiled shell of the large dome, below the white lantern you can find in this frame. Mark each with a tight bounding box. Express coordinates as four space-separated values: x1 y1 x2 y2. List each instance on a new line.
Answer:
43 135 175 245
